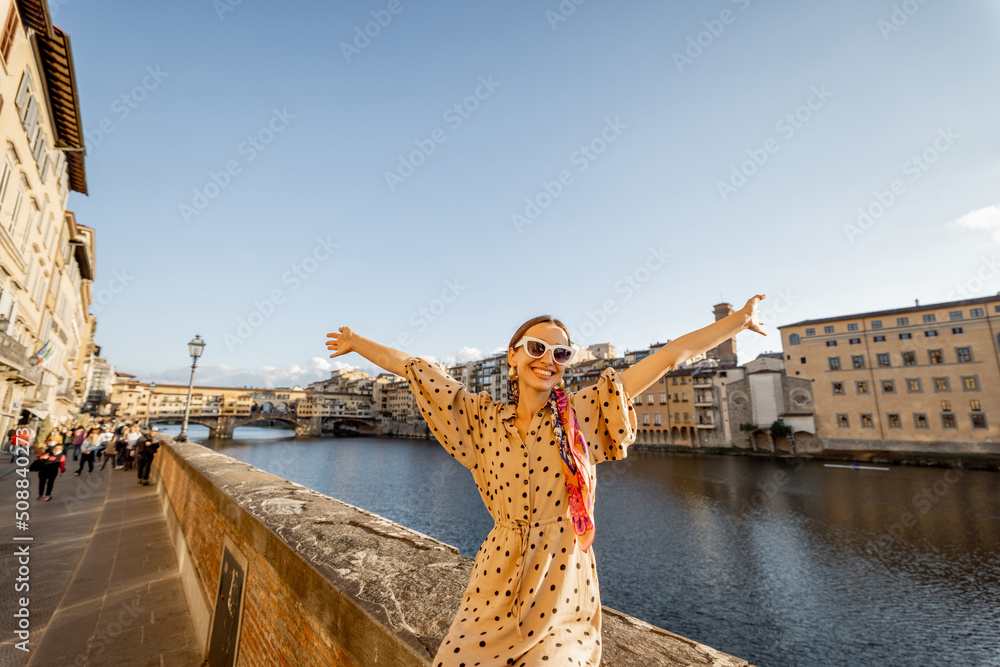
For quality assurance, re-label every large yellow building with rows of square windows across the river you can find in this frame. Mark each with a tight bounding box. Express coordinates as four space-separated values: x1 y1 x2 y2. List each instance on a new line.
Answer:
779 295 1000 452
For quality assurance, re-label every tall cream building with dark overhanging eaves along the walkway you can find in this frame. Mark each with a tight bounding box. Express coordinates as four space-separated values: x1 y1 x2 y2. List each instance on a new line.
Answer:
0 0 94 432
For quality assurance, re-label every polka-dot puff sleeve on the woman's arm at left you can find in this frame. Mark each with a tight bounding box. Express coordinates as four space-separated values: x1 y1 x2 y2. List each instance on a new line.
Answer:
404 357 484 470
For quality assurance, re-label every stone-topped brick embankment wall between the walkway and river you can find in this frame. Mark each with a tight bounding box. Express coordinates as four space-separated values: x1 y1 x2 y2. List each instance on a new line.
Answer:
155 442 747 667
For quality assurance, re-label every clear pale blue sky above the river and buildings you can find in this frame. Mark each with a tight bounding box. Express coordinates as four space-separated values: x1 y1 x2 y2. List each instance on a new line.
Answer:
56 0 1000 386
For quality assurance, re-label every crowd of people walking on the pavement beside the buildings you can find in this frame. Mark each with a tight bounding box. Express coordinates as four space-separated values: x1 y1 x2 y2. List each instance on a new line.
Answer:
7 417 159 501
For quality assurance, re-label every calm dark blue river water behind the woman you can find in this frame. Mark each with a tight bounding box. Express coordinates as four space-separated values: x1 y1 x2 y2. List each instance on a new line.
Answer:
163 426 1000 667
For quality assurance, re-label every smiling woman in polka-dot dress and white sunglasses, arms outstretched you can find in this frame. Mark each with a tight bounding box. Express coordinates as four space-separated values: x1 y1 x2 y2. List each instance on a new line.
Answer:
327 295 766 667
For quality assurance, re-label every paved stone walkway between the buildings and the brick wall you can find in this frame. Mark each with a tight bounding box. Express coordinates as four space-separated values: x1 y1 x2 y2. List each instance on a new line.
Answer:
0 457 202 667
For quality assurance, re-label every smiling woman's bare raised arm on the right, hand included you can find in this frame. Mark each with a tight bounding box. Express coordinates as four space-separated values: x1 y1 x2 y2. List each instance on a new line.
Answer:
622 294 767 396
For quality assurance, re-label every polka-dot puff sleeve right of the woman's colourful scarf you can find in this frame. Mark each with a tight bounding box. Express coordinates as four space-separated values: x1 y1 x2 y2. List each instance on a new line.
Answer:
570 368 637 463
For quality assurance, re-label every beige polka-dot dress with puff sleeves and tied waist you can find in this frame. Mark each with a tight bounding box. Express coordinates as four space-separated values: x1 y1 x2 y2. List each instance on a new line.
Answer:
405 357 636 667
